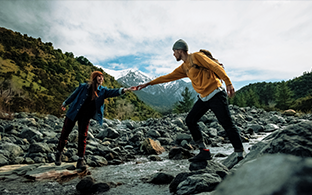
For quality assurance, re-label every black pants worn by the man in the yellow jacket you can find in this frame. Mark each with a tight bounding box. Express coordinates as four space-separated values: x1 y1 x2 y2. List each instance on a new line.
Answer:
185 91 244 152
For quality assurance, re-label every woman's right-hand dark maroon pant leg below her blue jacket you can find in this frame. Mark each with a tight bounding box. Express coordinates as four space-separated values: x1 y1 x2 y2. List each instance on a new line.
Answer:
78 119 90 157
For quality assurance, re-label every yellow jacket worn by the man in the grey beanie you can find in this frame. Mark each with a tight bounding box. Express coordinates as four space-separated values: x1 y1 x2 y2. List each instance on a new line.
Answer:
149 52 232 97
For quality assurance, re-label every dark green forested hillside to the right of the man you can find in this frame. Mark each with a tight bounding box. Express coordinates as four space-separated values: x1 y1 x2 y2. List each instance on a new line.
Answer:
230 72 312 112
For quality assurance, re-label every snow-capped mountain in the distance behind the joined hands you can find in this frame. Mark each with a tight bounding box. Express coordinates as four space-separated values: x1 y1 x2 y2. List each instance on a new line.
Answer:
101 67 196 111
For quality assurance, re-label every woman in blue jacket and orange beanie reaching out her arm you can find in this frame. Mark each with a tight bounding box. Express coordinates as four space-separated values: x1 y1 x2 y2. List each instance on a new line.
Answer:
55 71 135 169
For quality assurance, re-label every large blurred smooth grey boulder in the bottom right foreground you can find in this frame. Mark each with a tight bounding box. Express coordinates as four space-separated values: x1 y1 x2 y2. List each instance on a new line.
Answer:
214 154 312 195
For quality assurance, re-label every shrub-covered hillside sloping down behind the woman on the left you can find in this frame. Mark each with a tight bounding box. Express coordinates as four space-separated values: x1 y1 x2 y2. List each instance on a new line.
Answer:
0 27 160 120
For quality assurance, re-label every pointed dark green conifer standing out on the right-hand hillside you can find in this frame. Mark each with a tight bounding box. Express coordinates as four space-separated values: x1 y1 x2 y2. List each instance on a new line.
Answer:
275 81 293 110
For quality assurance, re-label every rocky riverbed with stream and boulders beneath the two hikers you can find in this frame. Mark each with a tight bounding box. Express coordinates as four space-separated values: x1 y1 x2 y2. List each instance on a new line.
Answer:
0 106 312 195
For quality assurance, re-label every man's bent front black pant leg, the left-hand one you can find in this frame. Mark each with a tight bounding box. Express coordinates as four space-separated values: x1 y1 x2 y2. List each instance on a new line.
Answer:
185 99 209 142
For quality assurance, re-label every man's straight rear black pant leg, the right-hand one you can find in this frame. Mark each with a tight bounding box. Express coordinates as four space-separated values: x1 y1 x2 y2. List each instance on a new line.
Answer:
207 91 244 152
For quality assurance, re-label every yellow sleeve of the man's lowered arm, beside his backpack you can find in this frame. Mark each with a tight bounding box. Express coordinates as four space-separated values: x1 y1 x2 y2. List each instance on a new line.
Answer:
193 52 232 85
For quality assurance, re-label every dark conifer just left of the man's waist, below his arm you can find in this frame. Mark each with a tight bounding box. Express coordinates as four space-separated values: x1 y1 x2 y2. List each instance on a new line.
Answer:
173 87 194 113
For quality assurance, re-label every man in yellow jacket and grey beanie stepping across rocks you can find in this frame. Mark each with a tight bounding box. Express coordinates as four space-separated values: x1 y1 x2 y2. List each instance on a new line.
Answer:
137 39 244 162
